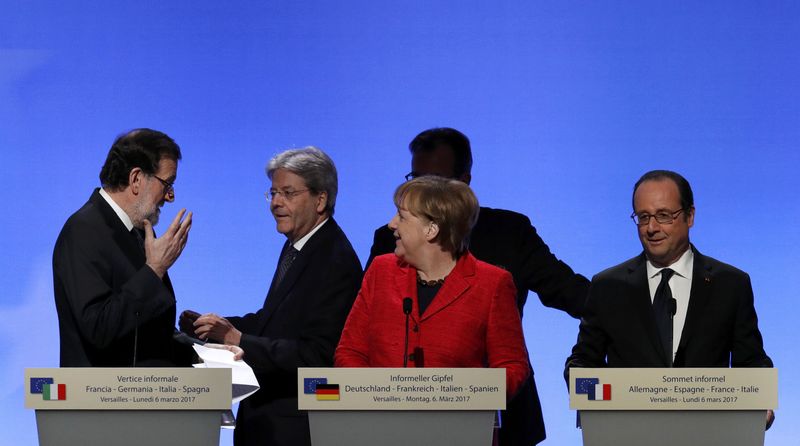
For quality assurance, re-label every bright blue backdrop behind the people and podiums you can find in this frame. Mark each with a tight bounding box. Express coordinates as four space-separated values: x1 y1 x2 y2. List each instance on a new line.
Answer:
0 0 800 445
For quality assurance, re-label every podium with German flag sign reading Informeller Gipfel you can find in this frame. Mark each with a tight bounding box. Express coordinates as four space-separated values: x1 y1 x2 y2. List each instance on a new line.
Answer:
297 368 506 446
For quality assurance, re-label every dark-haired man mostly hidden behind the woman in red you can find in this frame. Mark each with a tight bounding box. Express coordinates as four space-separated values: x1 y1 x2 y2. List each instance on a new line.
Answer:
367 128 589 446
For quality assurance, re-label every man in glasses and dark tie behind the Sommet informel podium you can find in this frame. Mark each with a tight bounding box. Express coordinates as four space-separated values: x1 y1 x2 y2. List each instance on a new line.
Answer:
564 170 774 426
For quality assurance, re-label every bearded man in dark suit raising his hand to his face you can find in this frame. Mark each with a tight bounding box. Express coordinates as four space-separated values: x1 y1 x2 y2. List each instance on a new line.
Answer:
53 129 192 367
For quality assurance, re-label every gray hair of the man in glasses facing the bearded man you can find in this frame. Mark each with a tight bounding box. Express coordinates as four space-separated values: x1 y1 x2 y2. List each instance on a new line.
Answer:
266 146 339 216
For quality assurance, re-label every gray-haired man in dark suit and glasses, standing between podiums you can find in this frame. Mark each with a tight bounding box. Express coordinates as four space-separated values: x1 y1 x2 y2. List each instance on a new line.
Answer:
181 147 362 446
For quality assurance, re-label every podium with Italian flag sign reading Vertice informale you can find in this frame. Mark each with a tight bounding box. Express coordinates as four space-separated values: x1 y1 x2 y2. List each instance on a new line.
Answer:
25 367 231 446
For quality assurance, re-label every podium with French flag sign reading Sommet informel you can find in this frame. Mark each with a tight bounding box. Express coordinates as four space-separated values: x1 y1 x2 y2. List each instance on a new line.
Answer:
569 368 778 446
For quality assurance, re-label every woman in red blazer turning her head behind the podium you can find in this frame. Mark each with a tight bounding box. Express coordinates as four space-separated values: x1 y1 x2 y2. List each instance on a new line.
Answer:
335 176 529 397
